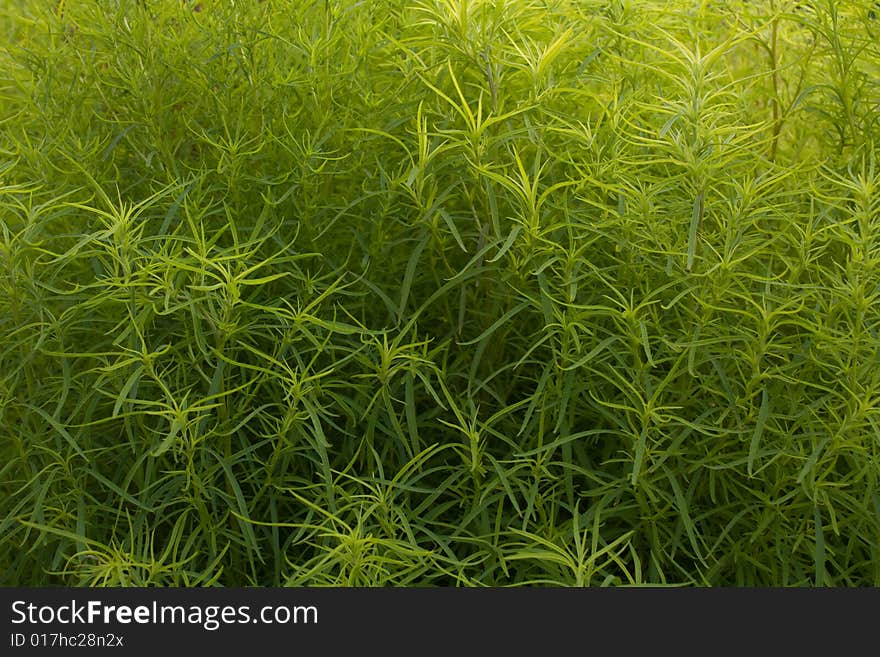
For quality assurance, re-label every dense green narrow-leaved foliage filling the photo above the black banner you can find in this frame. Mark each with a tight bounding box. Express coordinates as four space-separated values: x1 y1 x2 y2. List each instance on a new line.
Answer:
0 0 880 586
